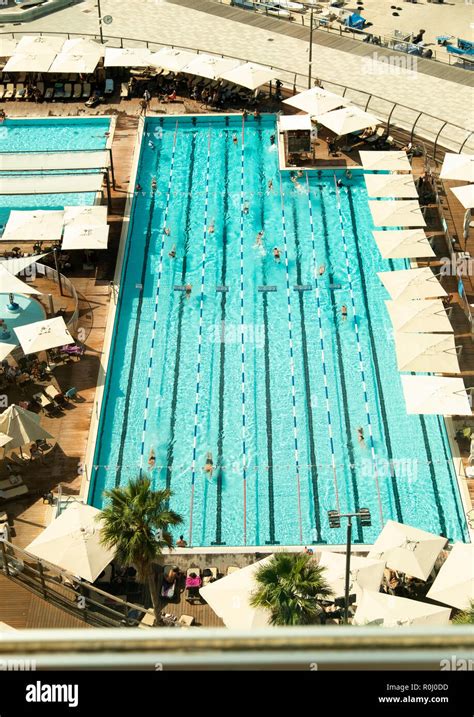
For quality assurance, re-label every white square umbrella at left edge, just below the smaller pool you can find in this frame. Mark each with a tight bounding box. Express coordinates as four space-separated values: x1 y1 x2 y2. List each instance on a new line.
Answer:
1 209 64 242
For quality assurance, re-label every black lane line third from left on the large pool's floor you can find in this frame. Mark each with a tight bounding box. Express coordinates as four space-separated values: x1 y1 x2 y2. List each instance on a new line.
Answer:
211 131 229 545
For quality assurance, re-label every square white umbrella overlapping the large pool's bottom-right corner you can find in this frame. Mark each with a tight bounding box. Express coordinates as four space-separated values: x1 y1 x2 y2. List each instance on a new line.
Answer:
368 520 447 580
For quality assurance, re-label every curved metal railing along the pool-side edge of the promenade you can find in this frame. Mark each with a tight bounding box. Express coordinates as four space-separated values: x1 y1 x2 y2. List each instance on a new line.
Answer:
0 31 474 160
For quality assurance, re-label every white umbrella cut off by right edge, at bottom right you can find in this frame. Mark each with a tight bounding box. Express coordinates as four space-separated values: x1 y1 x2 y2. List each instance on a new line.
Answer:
426 543 474 610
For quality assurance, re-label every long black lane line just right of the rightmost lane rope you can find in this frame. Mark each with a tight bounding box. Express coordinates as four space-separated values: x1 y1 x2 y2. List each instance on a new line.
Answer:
347 187 403 523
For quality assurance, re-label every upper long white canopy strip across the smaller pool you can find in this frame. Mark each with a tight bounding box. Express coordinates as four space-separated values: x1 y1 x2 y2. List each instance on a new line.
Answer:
0 150 110 173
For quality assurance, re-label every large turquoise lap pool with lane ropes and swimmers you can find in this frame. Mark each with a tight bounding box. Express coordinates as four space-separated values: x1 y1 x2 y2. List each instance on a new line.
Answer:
90 116 467 546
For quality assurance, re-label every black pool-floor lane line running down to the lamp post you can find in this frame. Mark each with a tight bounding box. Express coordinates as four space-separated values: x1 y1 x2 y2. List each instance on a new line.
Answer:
319 185 364 543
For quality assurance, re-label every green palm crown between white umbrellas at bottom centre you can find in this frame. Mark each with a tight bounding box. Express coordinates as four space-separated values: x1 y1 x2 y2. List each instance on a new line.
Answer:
250 553 332 625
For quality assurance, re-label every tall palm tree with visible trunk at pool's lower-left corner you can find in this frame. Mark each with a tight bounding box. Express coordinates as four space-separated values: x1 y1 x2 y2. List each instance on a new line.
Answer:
101 477 183 625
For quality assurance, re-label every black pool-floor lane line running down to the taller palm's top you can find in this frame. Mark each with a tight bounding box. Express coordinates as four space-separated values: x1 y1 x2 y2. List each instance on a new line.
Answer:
166 132 197 489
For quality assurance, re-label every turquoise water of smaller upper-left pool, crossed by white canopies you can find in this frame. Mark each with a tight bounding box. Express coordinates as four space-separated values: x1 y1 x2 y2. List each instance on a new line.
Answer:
0 117 110 227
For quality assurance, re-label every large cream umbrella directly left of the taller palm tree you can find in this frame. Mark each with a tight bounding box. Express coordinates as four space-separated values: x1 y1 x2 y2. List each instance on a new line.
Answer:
26 502 114 583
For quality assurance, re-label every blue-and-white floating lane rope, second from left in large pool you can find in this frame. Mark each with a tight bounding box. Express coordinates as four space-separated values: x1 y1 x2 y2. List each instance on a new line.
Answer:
188 127 211 545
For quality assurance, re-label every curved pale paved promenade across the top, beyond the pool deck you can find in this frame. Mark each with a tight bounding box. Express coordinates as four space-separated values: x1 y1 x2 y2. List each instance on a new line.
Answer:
3 0 474 144
